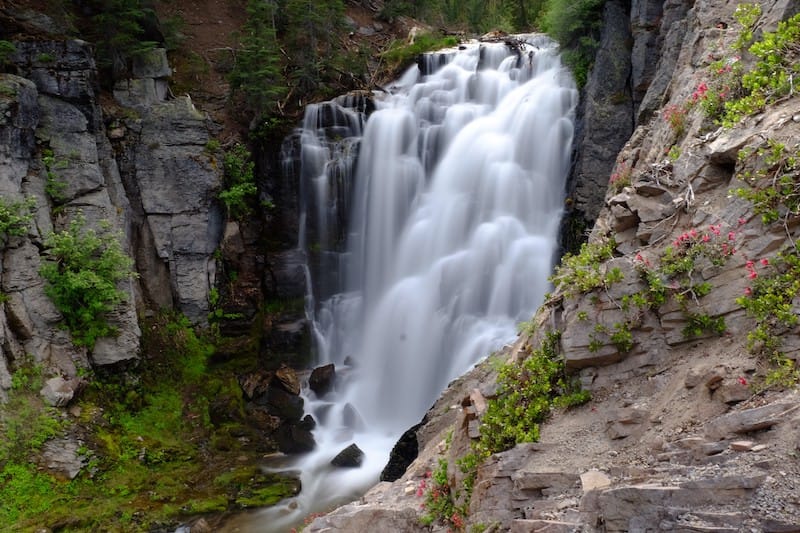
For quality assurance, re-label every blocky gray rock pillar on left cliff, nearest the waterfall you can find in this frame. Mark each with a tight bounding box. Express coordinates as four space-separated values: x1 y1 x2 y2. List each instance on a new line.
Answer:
121 93 224 323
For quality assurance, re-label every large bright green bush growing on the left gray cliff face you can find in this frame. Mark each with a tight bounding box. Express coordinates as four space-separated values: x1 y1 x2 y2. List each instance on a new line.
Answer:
40 213 134 349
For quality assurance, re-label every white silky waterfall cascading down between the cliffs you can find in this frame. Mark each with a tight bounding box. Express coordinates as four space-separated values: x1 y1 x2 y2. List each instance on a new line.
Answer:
241 36 577 531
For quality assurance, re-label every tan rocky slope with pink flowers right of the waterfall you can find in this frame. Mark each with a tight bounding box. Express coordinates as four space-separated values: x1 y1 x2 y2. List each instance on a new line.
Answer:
307 0 800 532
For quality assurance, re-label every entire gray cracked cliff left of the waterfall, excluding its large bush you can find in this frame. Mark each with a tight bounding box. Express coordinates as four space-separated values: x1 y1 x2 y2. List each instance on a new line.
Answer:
0 36 223 394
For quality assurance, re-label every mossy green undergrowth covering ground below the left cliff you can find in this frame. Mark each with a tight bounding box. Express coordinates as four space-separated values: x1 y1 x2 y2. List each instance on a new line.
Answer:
0 314 298 532
